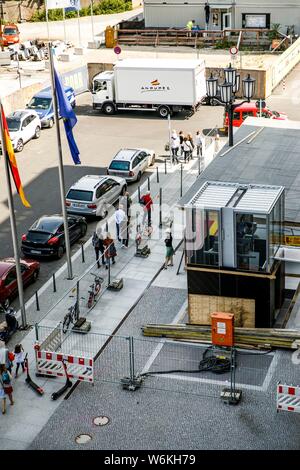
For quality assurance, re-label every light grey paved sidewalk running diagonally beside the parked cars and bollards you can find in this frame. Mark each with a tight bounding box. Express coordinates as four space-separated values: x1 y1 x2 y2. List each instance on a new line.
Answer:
0 142 225 449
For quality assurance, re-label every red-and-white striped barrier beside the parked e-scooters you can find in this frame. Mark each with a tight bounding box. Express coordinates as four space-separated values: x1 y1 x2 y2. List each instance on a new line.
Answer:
35 347 94 383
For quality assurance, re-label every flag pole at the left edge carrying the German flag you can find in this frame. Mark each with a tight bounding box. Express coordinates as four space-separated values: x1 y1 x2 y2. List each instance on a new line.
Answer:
0 99 27 329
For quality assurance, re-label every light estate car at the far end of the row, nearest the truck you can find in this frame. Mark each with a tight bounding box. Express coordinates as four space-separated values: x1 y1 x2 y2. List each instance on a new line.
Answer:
107 149 155 182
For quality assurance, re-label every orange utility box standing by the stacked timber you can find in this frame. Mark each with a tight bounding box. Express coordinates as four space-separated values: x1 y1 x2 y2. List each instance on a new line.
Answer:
211 312 234 346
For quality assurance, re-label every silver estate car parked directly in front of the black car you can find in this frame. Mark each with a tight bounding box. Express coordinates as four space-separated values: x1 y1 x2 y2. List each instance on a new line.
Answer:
66 175 127 217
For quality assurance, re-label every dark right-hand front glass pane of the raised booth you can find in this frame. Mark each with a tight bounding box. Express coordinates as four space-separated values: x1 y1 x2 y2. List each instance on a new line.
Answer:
236 214 267 271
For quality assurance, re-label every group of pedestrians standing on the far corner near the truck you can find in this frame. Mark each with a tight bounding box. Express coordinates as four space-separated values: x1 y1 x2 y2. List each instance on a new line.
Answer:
171 129 202 163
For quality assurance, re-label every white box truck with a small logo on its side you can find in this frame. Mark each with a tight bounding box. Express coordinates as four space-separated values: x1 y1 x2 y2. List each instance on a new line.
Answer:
92 59 206 118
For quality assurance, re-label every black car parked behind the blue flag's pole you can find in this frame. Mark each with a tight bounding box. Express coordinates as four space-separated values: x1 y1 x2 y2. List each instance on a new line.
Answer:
21 215 87 258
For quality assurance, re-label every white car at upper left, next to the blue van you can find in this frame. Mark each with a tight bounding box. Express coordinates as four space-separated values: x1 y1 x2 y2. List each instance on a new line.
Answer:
6 110 41 152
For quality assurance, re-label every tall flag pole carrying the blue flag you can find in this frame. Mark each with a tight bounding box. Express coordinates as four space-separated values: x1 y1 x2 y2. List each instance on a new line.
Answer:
48 42 73 279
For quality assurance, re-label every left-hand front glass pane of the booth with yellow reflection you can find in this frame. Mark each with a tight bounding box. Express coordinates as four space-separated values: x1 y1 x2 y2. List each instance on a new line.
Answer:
186 209 219 266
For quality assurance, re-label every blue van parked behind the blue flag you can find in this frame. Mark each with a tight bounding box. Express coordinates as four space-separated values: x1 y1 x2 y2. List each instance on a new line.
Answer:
26 86 76 127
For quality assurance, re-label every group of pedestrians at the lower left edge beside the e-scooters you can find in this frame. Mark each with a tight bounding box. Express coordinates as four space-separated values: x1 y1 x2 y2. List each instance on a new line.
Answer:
0 342 25 414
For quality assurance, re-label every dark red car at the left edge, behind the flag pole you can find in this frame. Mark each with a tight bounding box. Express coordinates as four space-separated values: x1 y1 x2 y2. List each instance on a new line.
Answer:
0 258 40 308
